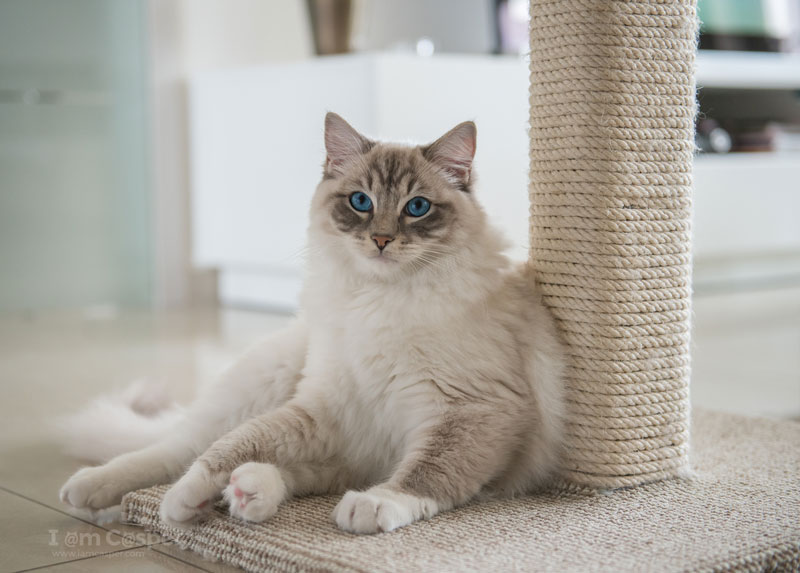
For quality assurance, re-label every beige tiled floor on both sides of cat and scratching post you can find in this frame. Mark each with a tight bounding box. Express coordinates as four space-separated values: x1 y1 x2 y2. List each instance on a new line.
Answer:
0 290 800 571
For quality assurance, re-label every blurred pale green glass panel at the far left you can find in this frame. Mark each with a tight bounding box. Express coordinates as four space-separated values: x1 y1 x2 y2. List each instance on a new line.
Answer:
0 0 152 311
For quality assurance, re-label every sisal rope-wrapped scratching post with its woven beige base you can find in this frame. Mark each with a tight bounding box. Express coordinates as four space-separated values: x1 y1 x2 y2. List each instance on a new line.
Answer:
122 0 800 573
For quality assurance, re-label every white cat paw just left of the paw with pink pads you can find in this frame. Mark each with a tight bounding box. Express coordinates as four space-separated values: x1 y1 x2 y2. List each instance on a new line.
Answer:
159 463 222 527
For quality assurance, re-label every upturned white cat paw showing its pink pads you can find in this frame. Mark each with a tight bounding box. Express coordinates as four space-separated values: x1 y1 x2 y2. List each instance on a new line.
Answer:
222 462 287 523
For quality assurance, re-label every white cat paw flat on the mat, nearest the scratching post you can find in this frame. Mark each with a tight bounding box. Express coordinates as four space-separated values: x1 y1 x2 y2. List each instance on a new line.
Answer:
333 487 439 533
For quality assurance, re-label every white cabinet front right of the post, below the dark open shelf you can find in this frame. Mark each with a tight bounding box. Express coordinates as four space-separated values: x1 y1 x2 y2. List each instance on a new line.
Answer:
692 153 800 295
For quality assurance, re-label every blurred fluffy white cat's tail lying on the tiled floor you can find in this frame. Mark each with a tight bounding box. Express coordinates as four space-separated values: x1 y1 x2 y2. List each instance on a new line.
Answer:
53 381 184 463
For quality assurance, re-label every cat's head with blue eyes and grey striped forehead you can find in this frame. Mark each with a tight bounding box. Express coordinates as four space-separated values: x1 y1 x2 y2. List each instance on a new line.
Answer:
312 113 486 277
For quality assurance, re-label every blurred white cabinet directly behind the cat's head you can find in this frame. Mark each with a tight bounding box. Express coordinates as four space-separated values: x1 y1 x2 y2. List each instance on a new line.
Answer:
190 55 528 309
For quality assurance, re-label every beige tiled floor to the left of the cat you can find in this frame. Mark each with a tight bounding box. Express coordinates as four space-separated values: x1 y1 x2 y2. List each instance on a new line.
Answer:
0 311 287 572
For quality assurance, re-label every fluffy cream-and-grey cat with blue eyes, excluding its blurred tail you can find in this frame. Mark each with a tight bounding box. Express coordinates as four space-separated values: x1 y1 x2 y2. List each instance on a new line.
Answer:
60 113 564 534
